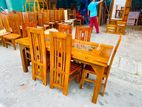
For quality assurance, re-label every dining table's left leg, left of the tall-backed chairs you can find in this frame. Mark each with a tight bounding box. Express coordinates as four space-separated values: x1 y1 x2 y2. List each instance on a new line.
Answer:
19 45 28 72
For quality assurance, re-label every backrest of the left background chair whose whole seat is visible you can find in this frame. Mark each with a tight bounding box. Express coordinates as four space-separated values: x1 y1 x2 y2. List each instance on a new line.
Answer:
9 12 21 34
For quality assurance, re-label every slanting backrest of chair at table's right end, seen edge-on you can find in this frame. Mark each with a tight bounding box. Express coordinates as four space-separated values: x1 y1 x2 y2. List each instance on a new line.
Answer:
107 35 122 73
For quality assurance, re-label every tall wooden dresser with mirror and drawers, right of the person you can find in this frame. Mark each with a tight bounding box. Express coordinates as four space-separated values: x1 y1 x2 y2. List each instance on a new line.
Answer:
106 0 132 34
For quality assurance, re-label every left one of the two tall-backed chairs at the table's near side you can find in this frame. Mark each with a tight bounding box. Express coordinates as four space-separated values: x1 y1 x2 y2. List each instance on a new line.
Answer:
27 28 48 85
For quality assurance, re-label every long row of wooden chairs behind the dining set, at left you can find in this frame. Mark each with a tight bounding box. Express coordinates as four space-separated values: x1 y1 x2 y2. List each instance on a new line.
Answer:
0 9 64 49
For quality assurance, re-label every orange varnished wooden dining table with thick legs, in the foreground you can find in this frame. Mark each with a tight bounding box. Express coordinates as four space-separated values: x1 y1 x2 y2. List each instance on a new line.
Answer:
16 29 114 103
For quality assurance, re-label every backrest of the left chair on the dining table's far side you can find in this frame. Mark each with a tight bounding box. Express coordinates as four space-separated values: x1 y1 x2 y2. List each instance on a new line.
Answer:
59 24 72 34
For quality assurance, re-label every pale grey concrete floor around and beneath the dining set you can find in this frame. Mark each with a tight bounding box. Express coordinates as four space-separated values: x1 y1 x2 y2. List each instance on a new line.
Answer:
0 27 142 107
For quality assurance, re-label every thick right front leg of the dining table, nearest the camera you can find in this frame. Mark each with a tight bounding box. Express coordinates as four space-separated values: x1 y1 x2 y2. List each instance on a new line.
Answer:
92 66 105 104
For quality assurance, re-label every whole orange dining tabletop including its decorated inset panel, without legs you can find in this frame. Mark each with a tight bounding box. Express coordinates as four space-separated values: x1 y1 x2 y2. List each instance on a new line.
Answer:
16 35 113 67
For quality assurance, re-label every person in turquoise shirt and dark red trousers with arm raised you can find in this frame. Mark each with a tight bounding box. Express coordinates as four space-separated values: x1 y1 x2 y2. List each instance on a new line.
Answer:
88 0 103 33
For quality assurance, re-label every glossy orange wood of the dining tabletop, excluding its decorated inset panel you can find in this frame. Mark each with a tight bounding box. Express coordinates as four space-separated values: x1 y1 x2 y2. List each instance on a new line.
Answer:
16 35 113 66
